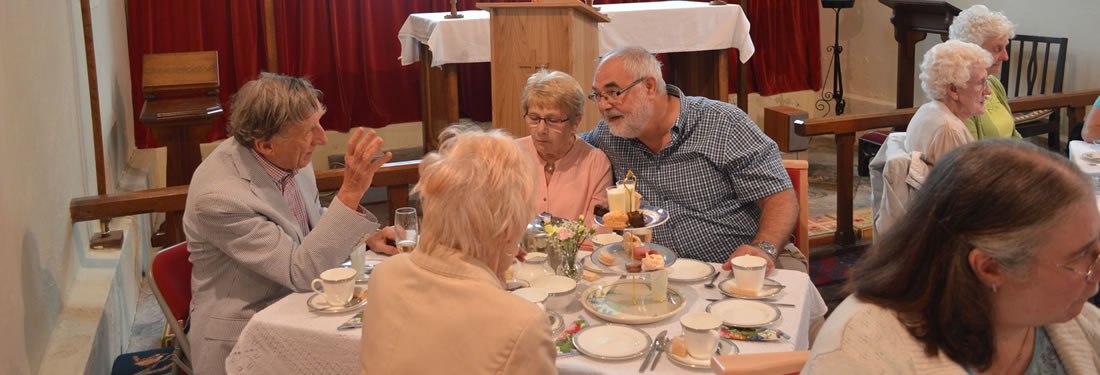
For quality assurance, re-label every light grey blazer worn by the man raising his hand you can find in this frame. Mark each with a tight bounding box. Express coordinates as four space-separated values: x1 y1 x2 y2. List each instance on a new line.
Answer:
184 137 378 374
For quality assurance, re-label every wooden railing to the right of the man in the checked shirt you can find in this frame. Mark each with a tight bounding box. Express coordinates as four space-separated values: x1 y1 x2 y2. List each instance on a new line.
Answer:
765 89 1100 245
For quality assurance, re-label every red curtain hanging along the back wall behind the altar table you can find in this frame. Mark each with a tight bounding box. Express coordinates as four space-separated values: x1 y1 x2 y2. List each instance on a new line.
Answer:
127 0 821 148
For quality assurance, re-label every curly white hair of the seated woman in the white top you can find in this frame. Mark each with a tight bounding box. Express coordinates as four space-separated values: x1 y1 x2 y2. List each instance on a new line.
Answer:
921 41 993 100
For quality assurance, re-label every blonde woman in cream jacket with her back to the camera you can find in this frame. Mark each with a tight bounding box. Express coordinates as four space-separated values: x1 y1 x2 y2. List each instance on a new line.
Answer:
360 126 557 374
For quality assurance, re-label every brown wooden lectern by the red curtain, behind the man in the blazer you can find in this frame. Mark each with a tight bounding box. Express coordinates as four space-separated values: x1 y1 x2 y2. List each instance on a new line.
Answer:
140 51 222 186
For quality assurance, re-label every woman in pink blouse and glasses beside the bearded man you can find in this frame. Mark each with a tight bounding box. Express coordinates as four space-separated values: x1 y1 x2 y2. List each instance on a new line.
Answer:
517 70 612 236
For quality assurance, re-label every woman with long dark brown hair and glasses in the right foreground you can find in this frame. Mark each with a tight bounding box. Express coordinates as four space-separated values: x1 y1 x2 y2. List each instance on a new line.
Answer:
802 140 1100 375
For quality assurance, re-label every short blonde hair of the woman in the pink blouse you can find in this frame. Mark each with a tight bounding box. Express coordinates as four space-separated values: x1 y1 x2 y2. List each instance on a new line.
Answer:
519 69 584 122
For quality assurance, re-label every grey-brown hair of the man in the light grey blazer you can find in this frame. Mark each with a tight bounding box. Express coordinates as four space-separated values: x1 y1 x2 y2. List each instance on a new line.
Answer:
228 73 325 148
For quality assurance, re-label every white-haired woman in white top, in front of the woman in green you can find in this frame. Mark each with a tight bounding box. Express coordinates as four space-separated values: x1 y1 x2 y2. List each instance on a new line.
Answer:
905 41 993 164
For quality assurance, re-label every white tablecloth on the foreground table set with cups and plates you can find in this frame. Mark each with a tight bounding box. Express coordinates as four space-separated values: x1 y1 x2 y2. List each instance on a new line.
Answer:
226 250 827 374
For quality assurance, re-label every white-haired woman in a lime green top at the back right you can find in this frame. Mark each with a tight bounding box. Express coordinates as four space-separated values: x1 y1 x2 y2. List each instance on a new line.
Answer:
949 4 1020 140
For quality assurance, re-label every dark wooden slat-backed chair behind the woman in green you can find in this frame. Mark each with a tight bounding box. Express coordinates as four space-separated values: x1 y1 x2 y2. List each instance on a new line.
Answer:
1000 35 1069 152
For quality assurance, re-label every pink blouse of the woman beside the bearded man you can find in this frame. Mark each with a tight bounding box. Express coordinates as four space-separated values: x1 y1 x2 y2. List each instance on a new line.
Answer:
516 136 612 228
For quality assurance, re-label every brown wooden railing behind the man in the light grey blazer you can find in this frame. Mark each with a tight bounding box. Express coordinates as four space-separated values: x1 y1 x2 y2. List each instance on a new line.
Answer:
69 161 420 243
